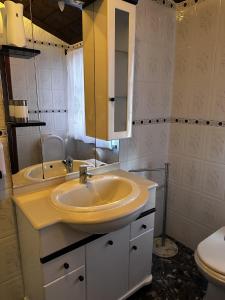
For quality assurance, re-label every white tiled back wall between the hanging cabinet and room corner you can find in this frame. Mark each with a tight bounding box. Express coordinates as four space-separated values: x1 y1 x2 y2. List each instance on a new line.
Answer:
120 0 176 235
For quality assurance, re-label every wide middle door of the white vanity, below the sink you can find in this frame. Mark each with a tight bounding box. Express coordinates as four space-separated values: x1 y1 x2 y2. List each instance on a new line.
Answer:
86 226 130 300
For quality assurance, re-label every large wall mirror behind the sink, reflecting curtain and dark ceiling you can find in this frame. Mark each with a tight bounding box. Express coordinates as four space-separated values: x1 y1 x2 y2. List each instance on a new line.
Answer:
0 0 119 187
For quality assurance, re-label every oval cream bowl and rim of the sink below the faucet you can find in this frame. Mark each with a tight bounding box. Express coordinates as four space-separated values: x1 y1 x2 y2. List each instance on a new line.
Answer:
52 176 139 212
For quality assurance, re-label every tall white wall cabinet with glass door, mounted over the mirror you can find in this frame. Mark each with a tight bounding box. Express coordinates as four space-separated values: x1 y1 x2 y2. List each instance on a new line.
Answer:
82 0 136 140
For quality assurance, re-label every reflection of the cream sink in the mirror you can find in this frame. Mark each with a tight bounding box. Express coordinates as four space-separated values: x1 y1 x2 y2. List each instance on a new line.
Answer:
24 160 94 182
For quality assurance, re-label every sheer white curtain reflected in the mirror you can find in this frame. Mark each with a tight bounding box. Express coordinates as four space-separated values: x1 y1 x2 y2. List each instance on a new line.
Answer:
67 48 113 149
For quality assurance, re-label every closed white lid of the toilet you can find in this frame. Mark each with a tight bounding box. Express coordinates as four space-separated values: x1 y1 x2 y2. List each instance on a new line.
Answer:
197 227 225 275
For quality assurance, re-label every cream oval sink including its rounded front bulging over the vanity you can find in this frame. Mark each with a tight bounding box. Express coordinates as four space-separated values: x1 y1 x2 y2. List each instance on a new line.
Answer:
50 175 146 233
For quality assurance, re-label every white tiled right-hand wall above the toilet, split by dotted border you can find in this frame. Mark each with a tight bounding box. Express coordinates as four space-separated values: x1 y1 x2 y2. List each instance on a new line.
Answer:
168 0 225 249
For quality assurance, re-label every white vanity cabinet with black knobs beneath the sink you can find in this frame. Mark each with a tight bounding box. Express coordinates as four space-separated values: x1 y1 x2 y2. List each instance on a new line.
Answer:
17 202 155 300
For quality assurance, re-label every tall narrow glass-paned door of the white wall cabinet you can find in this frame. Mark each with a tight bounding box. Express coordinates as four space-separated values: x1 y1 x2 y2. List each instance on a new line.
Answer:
108 0 136 139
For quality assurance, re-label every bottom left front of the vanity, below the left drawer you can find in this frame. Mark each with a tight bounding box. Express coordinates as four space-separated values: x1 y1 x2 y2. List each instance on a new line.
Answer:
44 266 85 300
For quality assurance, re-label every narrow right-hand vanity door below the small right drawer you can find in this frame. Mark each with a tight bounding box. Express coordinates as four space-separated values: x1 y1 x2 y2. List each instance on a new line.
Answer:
129 230 153 289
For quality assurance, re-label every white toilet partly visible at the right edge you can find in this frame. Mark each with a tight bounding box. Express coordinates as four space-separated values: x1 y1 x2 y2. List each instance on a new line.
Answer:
195 227 225 300
